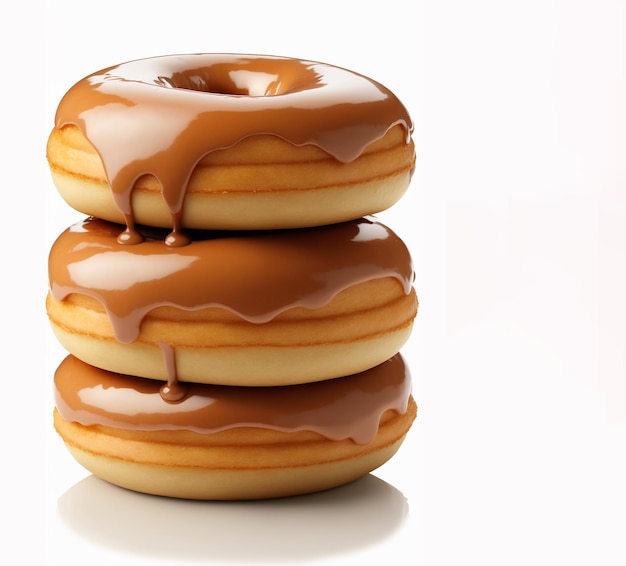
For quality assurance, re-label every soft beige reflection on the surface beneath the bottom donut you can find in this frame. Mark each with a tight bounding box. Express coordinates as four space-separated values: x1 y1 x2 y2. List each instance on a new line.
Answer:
58 475 408 562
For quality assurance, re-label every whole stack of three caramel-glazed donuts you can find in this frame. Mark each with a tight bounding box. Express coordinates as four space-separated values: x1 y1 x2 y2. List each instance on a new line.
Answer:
46 54 417 500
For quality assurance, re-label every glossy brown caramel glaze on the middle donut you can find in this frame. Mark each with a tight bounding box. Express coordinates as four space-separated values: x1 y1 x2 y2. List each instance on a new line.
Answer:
48 217 414 344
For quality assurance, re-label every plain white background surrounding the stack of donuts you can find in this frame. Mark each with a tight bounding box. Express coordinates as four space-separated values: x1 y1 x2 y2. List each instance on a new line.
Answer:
0 0 626 566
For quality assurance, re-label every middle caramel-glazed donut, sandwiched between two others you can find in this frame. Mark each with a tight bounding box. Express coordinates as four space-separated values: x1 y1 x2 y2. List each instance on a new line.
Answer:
46 217 417 394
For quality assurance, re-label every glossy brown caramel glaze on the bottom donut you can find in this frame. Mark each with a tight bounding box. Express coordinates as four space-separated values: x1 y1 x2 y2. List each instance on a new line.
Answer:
54 354 411 444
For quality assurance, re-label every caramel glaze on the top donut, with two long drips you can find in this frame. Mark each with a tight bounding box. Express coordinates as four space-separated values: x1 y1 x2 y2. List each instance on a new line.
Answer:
55 54 413 242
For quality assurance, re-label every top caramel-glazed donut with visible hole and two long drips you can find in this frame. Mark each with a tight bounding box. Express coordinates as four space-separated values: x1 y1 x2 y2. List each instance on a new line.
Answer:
47 54 415 242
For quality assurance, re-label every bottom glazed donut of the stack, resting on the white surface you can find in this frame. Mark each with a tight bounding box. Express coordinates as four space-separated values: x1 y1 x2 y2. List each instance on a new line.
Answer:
54 355 417 500
